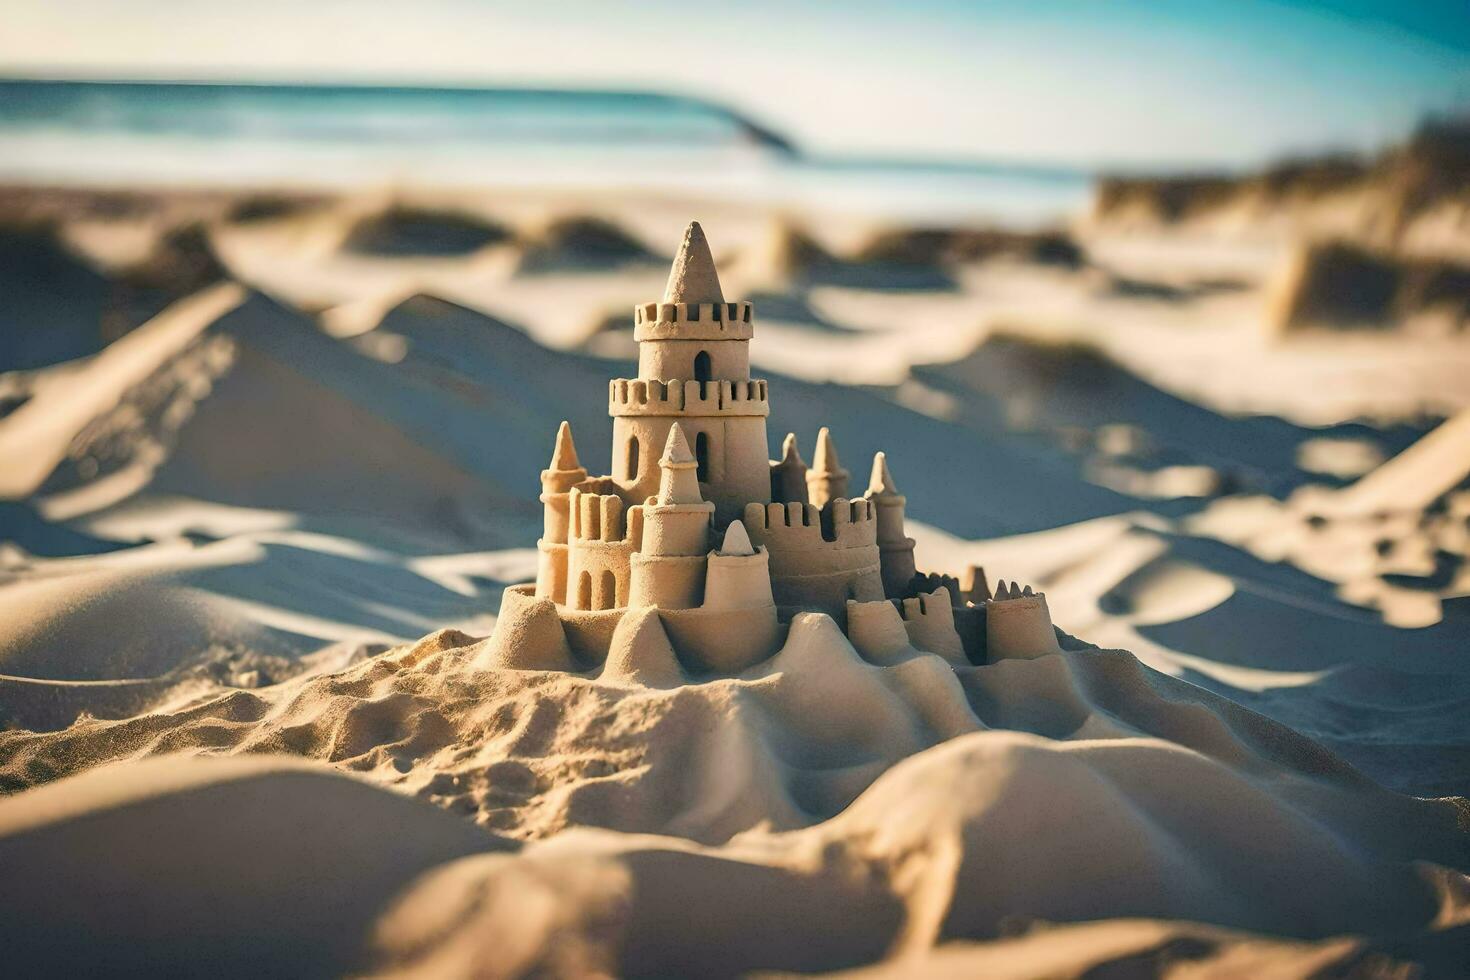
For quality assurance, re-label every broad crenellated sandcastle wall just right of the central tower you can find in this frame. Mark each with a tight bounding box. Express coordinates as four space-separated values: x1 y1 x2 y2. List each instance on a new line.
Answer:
744 498 883 616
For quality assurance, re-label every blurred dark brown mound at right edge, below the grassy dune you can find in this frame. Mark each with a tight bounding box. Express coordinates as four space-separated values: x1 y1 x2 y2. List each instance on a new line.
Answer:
1270 241 1470 334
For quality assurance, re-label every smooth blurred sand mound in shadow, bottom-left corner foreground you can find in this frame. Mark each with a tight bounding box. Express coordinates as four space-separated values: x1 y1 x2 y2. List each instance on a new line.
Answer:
0 758 504 977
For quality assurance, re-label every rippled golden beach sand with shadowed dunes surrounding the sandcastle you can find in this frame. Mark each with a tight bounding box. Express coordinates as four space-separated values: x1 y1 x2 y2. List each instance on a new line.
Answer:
0 194 1470 977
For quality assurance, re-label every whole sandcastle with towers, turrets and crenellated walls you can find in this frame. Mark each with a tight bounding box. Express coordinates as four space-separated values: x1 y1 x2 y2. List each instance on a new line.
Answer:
487 222 1060 675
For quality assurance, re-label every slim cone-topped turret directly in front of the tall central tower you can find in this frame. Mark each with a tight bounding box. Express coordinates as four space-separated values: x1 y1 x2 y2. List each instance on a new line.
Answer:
628 422 714 610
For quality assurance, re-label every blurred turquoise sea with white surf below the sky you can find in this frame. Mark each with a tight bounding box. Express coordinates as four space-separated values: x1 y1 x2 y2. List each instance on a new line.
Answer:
0 81 1091 225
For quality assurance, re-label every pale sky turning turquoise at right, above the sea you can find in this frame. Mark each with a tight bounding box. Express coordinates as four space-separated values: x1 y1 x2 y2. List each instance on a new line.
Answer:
0 0 1470 169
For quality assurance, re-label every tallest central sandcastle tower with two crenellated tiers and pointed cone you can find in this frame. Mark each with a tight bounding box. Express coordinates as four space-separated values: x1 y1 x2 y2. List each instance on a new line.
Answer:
607 222 770 527
